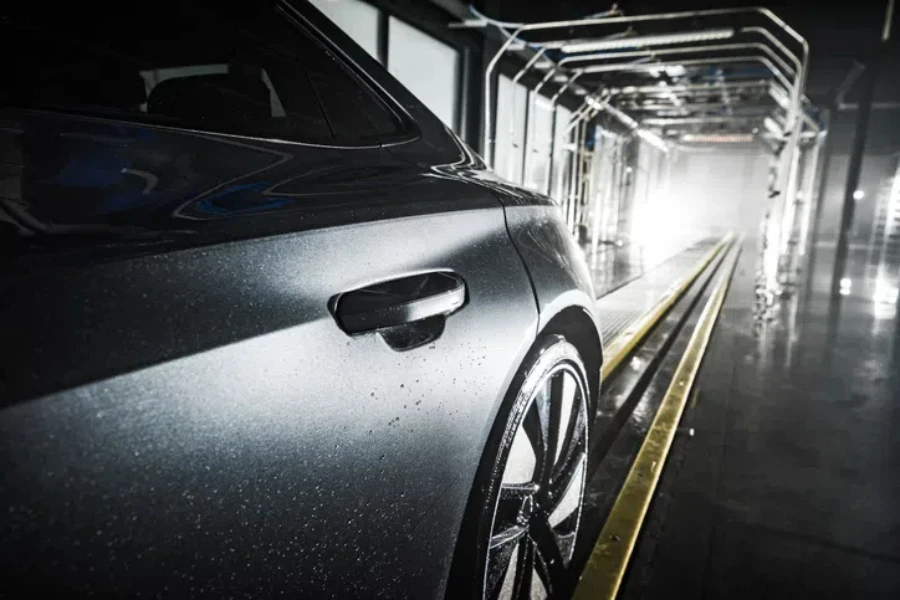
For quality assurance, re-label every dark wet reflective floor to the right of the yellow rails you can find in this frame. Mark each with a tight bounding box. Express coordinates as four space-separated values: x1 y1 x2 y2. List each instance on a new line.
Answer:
622 239 900 599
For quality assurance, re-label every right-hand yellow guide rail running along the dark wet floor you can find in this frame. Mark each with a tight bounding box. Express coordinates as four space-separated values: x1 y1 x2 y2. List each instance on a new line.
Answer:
574 237 740 600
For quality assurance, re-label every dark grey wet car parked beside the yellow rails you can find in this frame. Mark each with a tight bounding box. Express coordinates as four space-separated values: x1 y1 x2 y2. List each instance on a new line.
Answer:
0 1 602 598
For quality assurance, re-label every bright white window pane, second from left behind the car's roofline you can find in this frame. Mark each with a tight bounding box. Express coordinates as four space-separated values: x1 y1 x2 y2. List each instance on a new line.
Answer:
388 17 460 130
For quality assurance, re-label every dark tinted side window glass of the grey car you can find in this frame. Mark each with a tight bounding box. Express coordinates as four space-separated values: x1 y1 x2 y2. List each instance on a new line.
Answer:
0 1 400 143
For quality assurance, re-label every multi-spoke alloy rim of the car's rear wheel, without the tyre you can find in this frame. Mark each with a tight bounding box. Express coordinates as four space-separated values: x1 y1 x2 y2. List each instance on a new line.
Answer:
483 361 588 600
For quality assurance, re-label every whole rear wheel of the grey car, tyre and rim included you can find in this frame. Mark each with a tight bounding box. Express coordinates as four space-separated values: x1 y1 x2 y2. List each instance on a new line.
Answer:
448 335 591 600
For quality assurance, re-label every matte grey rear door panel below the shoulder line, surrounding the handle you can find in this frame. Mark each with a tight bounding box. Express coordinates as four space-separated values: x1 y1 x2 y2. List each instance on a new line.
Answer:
0 208 536 598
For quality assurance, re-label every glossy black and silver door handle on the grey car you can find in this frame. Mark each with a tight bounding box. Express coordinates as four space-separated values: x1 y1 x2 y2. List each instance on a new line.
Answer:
331 271 466 335
